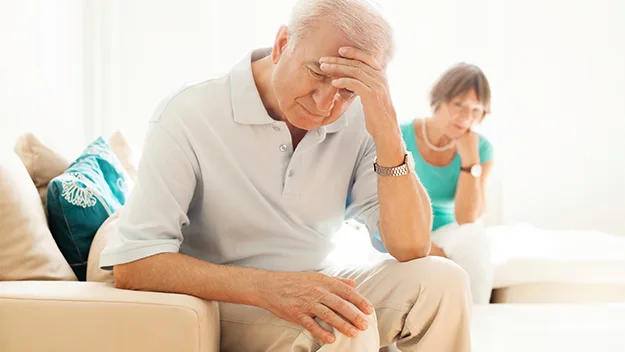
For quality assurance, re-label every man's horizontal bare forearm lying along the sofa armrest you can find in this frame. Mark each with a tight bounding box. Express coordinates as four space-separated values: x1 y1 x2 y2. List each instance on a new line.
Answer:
114 253 271 305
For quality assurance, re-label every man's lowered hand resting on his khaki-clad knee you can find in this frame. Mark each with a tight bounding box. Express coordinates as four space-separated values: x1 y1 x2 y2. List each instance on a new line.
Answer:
259 273 373 343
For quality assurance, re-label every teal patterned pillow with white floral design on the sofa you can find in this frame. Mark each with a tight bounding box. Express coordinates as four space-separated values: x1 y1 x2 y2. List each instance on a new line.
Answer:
47 137 129 281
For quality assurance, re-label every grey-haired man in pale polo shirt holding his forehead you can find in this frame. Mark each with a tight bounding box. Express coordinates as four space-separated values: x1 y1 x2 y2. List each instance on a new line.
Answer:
101 0 471 351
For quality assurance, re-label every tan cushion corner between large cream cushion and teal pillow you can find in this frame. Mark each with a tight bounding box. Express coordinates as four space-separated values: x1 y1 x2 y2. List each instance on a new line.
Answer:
14 133 69 208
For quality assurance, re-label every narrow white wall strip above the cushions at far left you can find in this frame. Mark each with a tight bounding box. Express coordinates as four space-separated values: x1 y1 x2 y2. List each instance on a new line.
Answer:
0 0 84 154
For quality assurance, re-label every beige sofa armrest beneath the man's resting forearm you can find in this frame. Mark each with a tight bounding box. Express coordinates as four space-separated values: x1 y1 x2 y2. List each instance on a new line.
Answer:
0 281 219 352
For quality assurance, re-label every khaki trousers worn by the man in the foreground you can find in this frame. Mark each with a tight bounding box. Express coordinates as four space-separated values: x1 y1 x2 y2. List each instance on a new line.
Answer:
220 256 471 352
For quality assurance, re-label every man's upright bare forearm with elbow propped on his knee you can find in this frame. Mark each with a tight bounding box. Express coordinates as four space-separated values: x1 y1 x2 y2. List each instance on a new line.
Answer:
376 131 432 261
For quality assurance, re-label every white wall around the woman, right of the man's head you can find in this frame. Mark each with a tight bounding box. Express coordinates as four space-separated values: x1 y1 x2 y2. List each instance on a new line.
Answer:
391 0 625 234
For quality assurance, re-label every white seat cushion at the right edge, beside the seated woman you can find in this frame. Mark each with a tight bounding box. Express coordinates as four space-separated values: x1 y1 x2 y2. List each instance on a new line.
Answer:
487 224 625 288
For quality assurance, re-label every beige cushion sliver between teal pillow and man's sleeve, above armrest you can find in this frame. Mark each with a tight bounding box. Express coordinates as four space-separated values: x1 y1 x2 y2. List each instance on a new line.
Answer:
87 211 120 283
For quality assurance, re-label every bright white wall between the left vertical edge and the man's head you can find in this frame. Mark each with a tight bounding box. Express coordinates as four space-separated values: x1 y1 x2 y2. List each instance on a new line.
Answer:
87 0 292 144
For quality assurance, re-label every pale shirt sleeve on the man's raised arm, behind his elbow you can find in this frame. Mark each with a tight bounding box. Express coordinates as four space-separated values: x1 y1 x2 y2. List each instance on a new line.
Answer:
345 138 380 245
